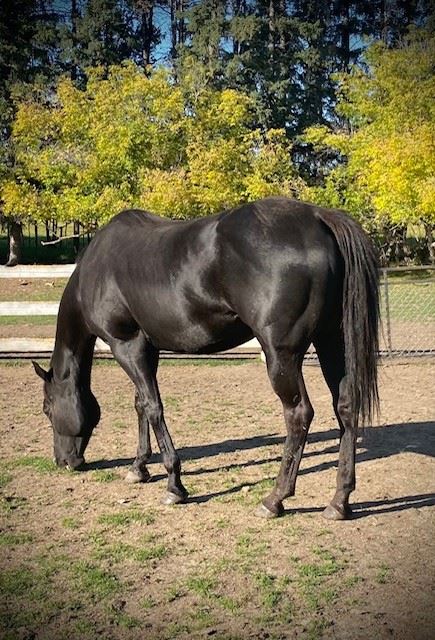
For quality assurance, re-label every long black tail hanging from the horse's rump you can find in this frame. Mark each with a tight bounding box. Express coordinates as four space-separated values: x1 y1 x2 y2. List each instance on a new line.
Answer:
316 209 379 424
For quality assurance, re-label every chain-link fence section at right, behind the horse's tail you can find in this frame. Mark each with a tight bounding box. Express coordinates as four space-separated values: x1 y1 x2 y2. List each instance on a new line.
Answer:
380 267 435 357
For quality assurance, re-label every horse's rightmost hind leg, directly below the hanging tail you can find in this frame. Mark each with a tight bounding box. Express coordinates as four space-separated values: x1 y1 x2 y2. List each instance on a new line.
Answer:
315 331 358 520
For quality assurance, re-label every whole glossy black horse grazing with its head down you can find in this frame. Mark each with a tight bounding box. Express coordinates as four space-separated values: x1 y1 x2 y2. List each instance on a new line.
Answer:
34 197 379 519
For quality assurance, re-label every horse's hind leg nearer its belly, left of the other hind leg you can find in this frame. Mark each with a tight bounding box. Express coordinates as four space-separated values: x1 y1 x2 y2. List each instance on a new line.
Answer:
257 348 314 518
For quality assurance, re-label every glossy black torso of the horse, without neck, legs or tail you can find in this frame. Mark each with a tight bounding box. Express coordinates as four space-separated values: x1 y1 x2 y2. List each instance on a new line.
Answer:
76 198 344 352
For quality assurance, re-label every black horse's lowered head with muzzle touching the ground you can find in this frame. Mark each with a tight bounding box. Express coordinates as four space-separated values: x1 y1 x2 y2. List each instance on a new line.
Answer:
33 362 100 469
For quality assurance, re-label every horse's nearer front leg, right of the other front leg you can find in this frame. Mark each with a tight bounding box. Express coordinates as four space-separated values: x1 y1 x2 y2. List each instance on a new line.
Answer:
110 333 187 504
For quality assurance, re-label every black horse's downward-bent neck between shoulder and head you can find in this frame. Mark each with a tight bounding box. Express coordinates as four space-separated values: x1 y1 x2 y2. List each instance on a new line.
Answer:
51 274 95 387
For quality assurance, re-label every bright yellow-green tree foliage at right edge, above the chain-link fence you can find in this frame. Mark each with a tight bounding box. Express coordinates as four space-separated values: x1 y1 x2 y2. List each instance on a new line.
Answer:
306 30 435 262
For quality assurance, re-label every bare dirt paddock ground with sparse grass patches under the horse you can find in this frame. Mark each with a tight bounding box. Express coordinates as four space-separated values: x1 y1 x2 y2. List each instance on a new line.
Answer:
0 359 435 640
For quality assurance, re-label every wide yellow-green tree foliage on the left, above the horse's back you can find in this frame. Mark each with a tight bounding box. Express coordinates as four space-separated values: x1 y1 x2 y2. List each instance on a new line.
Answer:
1 63 302 235
